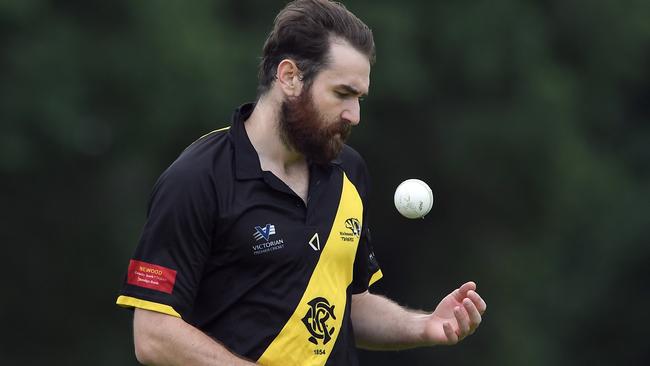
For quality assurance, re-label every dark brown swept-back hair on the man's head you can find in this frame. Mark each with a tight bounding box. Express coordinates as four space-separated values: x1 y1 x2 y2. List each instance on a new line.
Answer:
258 0 375 95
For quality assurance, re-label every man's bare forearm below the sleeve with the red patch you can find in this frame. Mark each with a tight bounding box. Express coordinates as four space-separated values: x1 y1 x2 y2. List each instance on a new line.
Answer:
133 309 255 366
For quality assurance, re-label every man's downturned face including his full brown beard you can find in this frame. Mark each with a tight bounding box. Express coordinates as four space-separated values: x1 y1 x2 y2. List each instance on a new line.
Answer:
280 41 370 164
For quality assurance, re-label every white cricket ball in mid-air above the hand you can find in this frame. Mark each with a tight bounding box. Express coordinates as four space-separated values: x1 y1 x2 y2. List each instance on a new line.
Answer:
395 179 433 219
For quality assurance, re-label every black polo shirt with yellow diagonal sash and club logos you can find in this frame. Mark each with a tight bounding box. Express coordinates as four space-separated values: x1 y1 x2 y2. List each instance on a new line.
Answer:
117 104 381 366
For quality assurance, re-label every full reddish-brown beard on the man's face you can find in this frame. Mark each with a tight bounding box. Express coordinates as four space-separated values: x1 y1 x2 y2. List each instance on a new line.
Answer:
280 89 352 165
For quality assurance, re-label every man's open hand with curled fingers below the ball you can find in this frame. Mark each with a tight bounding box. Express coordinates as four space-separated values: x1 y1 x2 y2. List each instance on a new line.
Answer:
423 282 487 345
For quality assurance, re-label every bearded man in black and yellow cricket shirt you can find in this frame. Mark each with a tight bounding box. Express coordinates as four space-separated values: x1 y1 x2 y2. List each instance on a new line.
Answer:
117 0 486 366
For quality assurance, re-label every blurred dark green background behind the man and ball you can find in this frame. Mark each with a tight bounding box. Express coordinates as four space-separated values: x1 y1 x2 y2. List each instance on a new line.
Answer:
0 0 650 366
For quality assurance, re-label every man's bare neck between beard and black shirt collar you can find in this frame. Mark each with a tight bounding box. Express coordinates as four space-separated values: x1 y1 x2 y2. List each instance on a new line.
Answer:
244 95 307 175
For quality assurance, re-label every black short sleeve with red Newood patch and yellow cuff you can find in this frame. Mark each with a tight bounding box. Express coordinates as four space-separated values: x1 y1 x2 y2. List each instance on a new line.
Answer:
117 157 217 317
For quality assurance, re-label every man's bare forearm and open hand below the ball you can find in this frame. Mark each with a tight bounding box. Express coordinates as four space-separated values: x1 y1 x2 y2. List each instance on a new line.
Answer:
351 282 487 350
